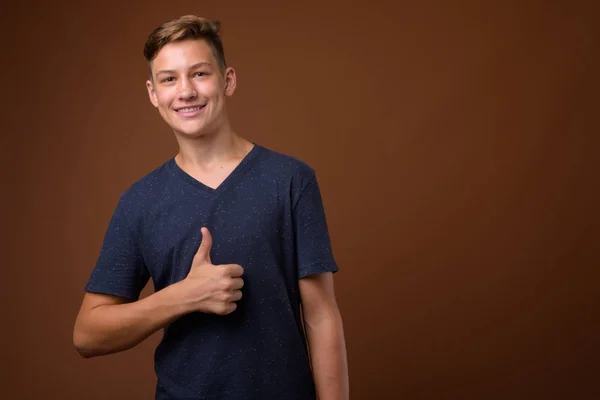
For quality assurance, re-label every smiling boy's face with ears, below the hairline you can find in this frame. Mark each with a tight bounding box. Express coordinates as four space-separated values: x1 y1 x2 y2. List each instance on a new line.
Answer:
146 40 236 137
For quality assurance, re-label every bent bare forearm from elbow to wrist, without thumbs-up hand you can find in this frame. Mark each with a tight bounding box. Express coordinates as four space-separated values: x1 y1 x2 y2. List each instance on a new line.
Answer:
74 286 186 358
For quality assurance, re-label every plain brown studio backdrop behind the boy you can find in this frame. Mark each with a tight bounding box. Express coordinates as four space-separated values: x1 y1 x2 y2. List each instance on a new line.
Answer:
0 0 600 399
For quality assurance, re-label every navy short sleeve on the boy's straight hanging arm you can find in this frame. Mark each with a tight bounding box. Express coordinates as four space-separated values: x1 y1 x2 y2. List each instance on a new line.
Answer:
293 175 338 279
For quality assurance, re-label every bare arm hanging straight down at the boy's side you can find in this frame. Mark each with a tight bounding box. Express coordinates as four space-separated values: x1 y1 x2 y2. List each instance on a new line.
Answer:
299 272 349 400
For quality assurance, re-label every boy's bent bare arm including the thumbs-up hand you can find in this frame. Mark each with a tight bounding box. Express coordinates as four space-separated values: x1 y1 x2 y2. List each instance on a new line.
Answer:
73 228 244 357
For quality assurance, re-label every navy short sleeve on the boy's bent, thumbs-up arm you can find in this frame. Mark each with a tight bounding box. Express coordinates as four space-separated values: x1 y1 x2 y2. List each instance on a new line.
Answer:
85 195 150 300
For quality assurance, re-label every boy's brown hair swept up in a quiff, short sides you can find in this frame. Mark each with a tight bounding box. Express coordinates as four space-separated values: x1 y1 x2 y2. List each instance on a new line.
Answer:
144 15 227 76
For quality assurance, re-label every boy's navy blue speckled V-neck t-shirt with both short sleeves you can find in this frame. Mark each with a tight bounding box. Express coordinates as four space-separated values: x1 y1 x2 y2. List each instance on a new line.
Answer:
85 144 338 400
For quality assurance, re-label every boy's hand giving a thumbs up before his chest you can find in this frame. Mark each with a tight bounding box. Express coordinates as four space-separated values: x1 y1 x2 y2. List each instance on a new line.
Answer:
183 228 244 315
